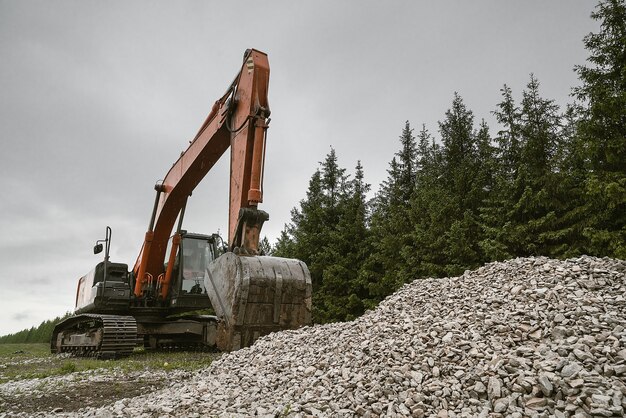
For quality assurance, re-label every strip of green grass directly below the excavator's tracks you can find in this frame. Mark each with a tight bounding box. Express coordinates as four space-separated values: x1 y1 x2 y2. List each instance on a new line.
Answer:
0 344 218 383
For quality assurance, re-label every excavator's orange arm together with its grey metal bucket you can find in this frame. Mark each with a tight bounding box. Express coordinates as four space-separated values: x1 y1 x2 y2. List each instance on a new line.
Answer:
133 49 311 351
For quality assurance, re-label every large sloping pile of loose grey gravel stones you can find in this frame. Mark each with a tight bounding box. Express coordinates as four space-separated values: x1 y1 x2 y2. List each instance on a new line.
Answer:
80 257 626 417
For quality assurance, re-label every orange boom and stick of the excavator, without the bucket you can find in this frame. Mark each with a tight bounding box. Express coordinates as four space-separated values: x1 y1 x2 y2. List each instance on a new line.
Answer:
133 49 270 297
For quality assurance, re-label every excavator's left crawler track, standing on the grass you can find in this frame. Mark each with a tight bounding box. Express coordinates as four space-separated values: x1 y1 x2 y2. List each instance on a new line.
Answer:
50 314 137 359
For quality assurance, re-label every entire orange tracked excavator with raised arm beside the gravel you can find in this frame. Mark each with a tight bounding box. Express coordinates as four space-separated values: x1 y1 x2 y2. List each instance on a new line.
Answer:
50 49 311 358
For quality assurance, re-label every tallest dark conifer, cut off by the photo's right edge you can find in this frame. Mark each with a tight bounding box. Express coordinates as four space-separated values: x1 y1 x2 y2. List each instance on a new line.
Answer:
574 0 626 258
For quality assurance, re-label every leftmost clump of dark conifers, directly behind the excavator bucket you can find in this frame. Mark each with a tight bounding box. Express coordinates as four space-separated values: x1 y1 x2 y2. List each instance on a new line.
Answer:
273 148 370 322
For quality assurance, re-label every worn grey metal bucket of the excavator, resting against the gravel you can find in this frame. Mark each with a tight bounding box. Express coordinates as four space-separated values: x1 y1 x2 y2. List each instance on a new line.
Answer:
204 252 311 351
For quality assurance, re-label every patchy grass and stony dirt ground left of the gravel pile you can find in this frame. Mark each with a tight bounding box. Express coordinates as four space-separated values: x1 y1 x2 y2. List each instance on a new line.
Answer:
0 344 219 416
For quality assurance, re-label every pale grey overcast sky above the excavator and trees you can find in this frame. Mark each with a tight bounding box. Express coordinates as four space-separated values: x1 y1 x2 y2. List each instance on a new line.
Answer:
0 0 597 335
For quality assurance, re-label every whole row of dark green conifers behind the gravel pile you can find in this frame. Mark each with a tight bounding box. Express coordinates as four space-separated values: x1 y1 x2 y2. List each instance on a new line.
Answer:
272 0 626 323
